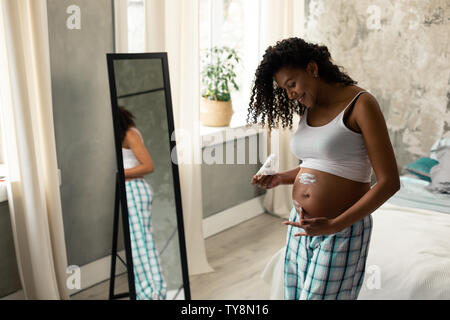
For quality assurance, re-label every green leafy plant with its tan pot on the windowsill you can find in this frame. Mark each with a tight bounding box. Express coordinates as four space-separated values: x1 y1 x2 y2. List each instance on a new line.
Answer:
200 46 240 127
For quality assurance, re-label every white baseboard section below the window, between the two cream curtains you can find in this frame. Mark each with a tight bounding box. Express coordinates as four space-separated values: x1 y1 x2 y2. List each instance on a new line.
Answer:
203 194 265 239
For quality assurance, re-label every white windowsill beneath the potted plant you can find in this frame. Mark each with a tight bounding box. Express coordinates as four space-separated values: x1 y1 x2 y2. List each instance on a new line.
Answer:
200 110 266 148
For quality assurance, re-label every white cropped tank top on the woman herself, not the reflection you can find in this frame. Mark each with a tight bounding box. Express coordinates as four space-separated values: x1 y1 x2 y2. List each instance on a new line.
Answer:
290 91 372 182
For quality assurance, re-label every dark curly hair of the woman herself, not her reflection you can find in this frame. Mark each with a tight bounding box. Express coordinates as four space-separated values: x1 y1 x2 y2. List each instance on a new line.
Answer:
247 37 357 131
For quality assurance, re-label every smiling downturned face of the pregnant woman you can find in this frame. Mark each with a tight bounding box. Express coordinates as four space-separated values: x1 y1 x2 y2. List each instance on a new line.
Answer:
274 64 318 108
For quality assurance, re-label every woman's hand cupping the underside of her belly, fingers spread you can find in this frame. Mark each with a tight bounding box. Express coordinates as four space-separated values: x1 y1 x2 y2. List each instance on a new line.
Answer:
283 210 339 236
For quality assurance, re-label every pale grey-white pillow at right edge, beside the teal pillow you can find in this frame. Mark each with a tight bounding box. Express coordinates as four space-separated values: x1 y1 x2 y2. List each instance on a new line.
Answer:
425 146 450 194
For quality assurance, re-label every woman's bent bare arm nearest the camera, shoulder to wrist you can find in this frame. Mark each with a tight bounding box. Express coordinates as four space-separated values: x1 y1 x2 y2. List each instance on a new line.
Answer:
334 94 400 231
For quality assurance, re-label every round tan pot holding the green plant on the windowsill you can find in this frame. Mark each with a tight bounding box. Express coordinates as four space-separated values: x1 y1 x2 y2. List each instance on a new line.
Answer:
200 97 234 127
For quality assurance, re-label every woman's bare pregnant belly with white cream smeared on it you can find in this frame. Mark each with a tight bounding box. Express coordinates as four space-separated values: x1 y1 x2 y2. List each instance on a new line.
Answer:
292 168 370 219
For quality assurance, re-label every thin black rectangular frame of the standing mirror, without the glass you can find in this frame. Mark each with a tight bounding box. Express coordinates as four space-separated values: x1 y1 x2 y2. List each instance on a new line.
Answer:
106 52 191 300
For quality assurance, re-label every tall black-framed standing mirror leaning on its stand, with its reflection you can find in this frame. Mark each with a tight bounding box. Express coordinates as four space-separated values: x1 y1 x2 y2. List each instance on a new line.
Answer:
107 52 190 300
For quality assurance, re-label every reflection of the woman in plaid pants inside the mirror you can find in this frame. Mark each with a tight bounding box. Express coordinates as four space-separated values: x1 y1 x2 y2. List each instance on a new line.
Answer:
119 106 167 300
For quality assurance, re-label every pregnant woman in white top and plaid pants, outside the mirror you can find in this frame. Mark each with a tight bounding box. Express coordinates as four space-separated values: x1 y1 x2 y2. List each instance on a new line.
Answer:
249 38 400 300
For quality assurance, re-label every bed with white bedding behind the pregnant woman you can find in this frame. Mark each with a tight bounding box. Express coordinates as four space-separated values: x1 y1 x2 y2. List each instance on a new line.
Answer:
262 174 450 300
